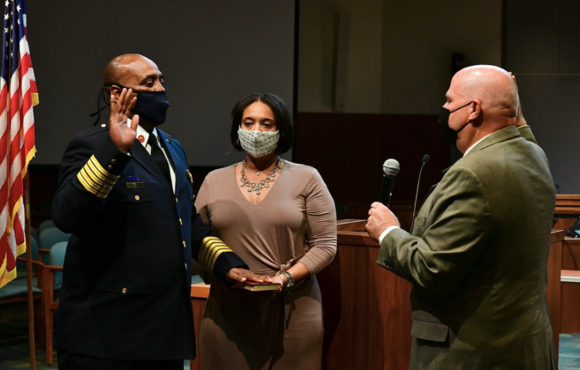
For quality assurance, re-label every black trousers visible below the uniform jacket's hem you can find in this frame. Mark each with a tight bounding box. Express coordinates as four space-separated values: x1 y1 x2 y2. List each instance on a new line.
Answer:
56 348 183 370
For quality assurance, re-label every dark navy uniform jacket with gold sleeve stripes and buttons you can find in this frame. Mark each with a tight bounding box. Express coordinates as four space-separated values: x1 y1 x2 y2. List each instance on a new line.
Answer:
53 125 238 359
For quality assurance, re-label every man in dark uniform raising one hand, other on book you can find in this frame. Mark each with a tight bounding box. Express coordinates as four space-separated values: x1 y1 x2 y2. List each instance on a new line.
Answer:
53 54 262 370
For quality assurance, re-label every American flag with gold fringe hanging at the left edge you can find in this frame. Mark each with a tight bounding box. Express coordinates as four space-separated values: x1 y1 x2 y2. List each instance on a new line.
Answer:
0 0 38 288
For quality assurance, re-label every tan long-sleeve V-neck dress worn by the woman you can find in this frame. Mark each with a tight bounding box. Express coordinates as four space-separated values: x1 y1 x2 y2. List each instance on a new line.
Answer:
196 161 336 370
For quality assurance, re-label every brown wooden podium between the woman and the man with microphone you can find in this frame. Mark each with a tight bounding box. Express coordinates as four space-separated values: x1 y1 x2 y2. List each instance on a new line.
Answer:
317 220 411 370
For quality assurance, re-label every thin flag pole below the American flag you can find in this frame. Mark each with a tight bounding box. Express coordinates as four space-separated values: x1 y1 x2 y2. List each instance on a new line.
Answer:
24 171 36 370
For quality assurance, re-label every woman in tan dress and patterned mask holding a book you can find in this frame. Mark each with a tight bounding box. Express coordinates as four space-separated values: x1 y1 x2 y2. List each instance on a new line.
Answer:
196 94 336 370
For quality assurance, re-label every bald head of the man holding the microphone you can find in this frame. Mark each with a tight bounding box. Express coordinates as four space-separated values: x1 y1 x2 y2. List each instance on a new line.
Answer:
451 65 518 123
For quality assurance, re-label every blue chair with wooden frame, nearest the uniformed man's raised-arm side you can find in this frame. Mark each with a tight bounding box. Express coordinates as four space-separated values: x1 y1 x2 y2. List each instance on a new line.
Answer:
43 242 68 365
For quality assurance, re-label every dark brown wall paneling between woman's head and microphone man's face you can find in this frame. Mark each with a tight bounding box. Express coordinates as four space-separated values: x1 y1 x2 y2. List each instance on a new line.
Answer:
295 113 450 218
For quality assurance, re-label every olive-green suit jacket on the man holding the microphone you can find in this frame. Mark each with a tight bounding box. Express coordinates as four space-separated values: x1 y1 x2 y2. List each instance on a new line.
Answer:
377 126 556 370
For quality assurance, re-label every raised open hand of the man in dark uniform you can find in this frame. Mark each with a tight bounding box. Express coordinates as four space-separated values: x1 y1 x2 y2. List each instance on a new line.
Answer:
109 88 139 153
